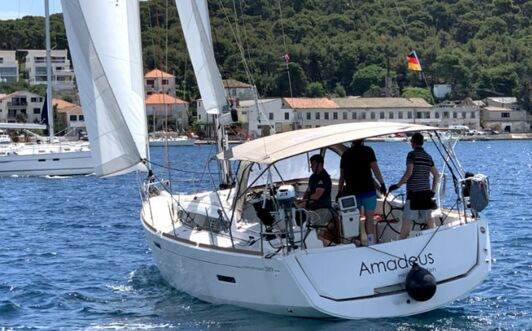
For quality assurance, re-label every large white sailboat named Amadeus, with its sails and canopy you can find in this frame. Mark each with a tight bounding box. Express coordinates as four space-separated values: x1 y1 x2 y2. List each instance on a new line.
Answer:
62 0 491 319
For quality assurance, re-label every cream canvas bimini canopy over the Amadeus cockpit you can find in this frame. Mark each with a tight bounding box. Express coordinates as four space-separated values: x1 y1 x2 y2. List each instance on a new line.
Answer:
217 122 441 164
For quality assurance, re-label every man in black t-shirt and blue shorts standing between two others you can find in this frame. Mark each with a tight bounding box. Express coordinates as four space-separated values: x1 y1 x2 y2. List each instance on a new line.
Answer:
338 140 386 245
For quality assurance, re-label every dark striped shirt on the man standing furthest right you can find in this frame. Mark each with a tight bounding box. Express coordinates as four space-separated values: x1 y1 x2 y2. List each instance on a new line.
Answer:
406 147 434 192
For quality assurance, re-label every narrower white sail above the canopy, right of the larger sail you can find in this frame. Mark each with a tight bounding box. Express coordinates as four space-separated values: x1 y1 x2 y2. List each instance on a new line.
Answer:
176 0 227 114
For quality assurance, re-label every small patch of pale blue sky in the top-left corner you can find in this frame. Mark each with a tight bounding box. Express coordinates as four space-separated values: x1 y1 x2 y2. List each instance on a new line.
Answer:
0 0 61 20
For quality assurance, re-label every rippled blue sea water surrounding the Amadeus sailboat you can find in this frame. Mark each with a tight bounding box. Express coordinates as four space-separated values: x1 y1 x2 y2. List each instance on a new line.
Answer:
0 141 532 330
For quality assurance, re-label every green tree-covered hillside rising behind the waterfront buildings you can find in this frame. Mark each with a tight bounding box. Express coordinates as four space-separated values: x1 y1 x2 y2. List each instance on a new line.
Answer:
0 0 532 108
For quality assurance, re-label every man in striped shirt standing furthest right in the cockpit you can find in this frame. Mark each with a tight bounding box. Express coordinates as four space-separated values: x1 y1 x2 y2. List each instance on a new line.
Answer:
390 132 439 239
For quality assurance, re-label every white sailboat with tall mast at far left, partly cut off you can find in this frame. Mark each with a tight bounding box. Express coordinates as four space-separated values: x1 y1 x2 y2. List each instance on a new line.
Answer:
0 0 94 176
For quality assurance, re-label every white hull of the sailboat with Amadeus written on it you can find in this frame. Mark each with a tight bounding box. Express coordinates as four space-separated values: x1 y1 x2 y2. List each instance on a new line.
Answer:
142 202 491 319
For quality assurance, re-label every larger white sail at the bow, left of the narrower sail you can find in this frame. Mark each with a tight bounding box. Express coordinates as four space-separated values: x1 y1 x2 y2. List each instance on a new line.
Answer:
61 0 148 176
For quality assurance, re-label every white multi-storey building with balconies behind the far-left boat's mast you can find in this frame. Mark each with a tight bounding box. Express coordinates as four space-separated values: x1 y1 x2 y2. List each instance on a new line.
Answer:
19 49 74 91
